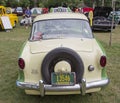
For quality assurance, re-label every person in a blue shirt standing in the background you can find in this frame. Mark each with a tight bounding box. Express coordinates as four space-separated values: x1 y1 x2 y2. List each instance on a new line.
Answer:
25 7 32 29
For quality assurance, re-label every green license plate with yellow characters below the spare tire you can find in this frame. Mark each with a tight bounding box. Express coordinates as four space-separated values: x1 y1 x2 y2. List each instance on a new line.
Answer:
51 72 76 85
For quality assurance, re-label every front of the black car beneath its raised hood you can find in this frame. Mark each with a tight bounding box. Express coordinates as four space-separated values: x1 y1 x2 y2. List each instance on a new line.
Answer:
92 16 116 31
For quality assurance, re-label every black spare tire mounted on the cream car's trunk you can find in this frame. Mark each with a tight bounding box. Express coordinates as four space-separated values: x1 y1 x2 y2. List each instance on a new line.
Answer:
41 47 84 84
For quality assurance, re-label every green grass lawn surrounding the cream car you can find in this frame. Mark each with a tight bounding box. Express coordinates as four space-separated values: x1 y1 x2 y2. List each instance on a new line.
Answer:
0 22 120 103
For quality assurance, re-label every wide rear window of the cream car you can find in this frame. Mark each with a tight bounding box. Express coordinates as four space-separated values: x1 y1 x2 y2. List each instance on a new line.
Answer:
30 19 93 40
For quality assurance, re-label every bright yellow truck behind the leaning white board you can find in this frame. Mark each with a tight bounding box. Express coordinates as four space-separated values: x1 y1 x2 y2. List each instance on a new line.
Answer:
0 6 18 29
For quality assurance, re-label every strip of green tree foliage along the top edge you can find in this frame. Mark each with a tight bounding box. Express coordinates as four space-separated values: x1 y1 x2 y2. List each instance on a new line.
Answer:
0 0 120 8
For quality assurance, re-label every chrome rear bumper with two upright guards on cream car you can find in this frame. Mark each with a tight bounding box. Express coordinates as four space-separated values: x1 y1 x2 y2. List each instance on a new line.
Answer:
16 78 110 96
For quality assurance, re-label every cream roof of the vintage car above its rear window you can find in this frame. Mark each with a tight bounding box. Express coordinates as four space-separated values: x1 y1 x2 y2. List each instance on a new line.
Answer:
34 12 88 22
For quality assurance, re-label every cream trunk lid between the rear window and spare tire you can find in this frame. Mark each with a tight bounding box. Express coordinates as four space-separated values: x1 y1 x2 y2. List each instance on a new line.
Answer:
29 39 94 53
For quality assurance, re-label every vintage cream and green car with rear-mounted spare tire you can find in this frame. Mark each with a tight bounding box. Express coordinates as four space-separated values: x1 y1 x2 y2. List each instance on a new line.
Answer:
16 12 109 96
